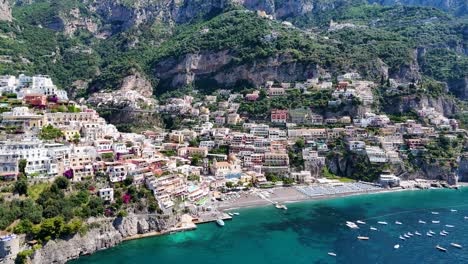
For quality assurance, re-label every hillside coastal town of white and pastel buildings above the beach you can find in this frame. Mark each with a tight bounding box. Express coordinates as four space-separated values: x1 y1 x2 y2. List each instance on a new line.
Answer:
0 72 467 259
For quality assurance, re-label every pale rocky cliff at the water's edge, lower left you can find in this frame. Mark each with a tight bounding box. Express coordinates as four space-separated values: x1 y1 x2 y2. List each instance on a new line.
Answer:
31 215 175 264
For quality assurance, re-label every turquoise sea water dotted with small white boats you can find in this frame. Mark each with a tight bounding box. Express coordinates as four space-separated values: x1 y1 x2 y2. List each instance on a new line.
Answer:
72 188 468 264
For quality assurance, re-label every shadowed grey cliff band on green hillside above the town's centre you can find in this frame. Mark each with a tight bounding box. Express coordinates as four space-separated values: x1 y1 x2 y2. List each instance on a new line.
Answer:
154 51 318 91
